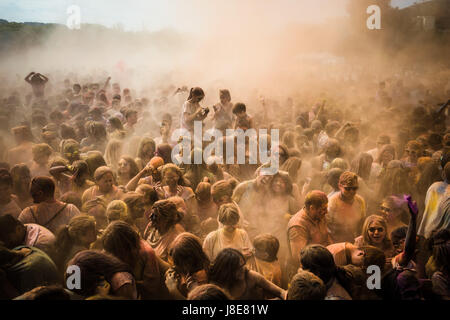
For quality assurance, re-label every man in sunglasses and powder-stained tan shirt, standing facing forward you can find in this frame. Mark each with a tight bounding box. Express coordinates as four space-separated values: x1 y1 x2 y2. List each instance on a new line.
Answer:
326 171 366 242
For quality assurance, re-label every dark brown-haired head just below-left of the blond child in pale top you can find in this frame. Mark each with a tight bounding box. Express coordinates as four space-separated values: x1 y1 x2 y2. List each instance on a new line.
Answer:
169 232 209 275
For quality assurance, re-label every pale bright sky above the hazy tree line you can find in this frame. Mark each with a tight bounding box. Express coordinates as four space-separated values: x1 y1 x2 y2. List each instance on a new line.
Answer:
0 0 432 33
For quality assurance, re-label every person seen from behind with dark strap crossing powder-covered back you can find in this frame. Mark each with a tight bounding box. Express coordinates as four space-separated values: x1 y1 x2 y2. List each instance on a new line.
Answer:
19 177 80 233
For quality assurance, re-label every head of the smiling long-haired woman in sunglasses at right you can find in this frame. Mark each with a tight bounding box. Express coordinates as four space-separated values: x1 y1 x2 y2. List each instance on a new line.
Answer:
361 214 391 249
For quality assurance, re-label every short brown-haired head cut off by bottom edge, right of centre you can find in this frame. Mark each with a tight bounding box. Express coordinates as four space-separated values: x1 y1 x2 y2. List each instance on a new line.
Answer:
287 270 327 300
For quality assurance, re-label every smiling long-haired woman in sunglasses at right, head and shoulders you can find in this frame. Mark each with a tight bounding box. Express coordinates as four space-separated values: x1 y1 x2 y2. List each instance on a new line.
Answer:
355 214 395 258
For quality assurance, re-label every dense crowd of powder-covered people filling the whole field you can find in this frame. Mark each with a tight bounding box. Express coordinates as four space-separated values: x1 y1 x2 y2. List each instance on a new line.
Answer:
0 72 450 300
